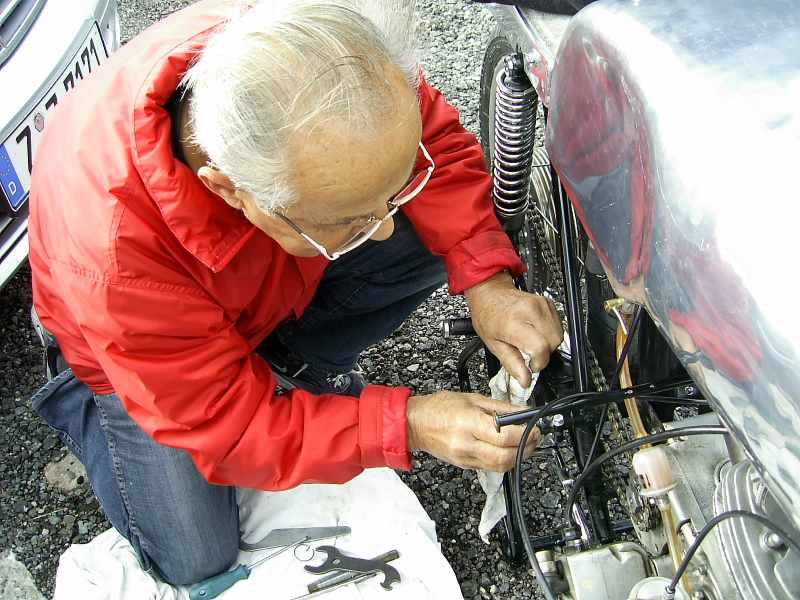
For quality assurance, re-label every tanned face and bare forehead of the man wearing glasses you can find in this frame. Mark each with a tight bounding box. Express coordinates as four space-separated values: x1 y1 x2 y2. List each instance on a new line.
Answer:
241 69 422 257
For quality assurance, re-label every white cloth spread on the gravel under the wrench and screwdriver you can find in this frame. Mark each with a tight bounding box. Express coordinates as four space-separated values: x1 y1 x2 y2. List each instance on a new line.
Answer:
53 469 462 600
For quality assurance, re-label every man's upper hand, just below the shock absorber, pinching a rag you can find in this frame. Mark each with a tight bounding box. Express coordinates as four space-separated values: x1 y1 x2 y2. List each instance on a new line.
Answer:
464 273 564 386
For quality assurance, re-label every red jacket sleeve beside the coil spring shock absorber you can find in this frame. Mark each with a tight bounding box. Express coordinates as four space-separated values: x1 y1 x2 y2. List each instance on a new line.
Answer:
403 79 525 294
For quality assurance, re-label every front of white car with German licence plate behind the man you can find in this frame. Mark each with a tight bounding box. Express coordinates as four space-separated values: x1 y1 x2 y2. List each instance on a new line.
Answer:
0 0 120 288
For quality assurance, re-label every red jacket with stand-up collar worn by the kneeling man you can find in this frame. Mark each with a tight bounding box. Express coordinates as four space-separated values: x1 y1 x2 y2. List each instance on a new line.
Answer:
30 0 522 489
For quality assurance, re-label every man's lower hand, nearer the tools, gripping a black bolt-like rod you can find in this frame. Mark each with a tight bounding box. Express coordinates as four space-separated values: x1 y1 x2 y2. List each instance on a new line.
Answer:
408 392 540 472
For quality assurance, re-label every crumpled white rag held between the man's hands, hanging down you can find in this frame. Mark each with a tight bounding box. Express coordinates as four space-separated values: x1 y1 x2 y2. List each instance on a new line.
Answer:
478 354 539 544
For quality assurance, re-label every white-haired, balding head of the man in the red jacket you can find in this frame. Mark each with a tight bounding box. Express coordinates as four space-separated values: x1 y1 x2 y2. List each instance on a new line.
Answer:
178 0 421 256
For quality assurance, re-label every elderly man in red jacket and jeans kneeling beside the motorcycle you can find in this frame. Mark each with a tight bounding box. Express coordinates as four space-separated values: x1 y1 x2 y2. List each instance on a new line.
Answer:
30 0 561 584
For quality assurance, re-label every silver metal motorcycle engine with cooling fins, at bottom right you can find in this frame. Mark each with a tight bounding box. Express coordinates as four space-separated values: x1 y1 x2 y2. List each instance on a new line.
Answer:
537 413 800 600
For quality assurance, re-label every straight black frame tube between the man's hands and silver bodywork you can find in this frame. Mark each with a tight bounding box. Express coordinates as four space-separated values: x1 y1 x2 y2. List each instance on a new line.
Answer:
550 171 612 543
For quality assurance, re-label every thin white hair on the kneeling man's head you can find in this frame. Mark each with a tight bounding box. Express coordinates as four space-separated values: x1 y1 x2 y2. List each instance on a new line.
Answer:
183 0 419 212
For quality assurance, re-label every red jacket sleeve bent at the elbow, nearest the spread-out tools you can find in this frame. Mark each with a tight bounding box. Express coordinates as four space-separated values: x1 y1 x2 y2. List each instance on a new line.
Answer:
70 280 410 490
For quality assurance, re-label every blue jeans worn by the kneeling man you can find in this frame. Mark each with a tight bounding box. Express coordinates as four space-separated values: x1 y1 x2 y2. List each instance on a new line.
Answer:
32 214 445 585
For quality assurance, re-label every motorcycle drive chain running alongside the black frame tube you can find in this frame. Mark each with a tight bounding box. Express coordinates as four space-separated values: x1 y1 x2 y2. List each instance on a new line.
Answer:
526 200 658 531
